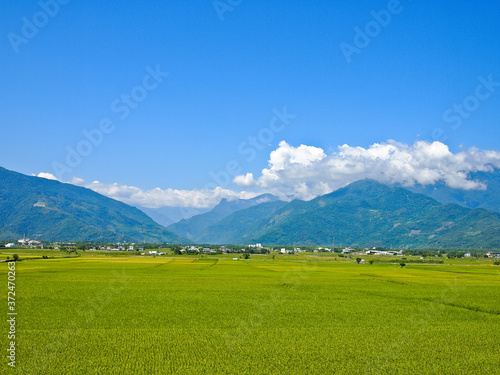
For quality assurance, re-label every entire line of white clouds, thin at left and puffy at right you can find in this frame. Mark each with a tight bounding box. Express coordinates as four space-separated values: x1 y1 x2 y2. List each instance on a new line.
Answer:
38 140 500 208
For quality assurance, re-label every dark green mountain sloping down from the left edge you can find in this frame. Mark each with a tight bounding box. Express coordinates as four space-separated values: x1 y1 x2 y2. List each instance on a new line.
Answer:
0 167 186 243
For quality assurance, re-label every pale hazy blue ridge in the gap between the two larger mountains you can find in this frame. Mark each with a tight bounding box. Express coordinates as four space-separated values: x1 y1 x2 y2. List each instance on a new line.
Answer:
167 194 278 243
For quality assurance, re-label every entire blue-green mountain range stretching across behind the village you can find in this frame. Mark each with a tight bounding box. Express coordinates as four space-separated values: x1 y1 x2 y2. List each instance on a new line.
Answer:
0 168 500 248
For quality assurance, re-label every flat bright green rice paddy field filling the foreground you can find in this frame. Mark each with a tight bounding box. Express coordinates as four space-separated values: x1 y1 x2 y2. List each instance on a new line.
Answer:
0 253 500 374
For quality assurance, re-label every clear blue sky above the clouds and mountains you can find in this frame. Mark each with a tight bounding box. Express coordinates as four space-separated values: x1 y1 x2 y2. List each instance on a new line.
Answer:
0 0 500 209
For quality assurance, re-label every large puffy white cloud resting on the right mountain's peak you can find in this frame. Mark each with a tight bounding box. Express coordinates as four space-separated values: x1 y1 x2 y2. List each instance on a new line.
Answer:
233 140 500 200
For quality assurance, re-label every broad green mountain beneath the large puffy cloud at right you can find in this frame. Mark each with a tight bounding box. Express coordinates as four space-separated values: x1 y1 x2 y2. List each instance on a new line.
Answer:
188 180 500 248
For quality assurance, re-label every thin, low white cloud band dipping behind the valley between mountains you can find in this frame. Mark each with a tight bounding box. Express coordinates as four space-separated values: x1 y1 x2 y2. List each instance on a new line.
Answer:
71 178 258 208
